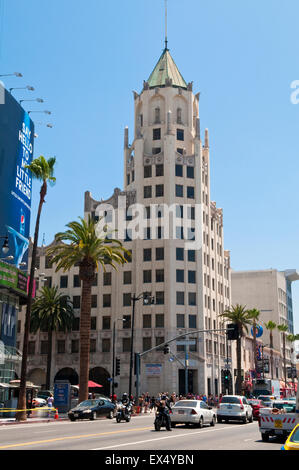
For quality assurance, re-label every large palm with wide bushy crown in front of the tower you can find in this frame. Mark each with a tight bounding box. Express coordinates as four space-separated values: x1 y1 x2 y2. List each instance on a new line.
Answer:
47 216 129 401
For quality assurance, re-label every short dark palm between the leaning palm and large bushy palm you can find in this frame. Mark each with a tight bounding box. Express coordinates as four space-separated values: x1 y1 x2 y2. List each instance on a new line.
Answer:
30 286 74 390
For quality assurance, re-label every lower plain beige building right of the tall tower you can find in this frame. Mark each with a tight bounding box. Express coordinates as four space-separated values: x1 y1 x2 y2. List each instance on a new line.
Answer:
231 269 299 394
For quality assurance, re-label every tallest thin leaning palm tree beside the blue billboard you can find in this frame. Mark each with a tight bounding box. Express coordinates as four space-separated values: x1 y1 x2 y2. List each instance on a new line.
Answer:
16 156 56 421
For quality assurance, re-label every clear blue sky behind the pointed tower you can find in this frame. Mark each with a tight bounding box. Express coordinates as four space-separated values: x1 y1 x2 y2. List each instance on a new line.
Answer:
0 0 299 332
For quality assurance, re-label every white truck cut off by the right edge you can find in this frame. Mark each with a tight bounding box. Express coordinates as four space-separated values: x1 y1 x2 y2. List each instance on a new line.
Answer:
259 387 299 442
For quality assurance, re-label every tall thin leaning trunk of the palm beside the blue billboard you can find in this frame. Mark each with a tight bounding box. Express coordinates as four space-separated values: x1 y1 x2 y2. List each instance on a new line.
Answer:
16 182 47 421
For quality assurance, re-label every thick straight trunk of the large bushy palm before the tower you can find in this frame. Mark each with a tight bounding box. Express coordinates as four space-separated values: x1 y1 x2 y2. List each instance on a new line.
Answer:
79 279 92 402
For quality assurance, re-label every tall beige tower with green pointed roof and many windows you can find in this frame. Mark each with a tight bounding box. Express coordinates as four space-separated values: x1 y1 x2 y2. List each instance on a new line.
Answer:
19 43 231 394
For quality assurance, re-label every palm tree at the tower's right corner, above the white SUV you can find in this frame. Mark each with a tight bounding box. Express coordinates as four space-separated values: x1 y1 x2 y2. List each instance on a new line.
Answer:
219 304 252 395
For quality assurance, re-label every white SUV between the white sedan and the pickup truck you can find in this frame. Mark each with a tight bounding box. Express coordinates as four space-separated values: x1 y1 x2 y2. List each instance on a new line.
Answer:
217 395 253 424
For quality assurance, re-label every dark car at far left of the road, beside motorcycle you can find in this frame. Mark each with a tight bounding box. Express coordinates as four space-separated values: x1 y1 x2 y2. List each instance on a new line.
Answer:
68 398 115 421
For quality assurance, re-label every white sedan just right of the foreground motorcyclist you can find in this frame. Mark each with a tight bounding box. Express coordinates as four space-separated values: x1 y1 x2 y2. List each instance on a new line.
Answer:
170 400 216 428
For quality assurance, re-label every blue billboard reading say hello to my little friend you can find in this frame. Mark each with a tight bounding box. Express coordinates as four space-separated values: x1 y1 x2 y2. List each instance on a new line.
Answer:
0 83 34 267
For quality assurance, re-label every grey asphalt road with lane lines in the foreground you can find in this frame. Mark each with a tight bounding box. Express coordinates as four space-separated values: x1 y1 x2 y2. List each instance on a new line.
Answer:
0 414 282 452
